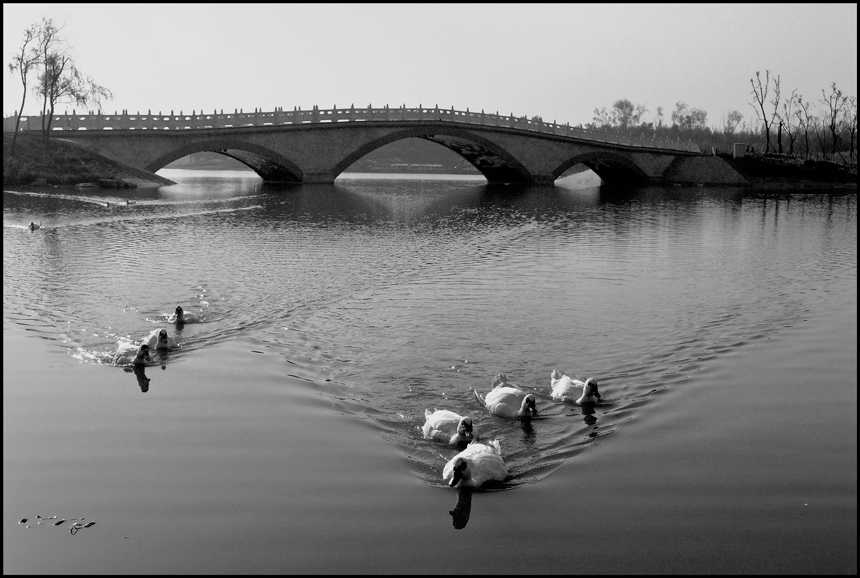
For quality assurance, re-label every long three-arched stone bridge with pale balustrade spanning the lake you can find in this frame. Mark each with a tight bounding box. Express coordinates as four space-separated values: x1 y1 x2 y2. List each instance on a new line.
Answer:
4 106 728 184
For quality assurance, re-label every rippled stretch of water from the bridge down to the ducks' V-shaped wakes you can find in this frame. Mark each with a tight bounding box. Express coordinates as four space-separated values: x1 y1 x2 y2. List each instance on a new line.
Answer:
3 181 857 487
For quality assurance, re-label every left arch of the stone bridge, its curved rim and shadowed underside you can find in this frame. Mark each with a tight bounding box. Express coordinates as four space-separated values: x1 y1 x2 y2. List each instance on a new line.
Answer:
146 138 304 183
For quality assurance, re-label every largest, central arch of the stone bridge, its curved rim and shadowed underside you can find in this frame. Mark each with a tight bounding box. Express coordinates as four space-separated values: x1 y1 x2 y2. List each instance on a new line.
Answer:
333 126 532 183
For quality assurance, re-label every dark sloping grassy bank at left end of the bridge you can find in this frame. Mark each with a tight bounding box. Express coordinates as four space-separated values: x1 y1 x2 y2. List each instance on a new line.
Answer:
3 133 172 187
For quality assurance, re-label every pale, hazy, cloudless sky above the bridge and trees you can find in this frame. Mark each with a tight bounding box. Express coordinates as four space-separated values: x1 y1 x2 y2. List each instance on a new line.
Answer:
3 4 857 126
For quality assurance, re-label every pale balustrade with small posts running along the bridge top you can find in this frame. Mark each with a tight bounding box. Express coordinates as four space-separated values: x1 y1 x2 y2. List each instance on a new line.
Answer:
3 105 701 153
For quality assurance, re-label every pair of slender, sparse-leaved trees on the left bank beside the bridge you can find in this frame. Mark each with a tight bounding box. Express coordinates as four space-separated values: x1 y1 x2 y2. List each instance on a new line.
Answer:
9 18 113 155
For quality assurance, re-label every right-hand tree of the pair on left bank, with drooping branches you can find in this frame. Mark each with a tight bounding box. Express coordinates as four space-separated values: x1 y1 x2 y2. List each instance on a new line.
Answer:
36 18 113 142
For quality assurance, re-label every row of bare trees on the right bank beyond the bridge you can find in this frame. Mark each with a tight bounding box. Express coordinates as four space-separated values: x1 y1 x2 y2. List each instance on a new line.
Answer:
585 70 857 165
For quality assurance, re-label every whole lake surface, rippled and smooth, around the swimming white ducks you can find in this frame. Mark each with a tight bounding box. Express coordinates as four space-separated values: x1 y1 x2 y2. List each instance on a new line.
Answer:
3 170 857 574
